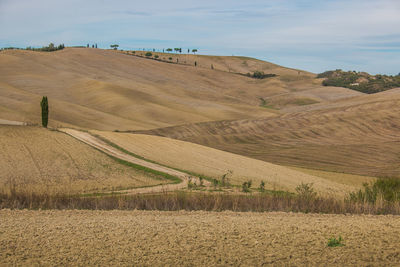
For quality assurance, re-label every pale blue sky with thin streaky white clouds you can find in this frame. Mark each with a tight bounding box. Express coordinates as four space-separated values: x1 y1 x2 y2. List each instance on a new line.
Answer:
0 0 400 75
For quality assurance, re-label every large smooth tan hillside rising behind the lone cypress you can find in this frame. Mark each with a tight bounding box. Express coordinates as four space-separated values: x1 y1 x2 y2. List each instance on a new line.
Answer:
0 48 359 130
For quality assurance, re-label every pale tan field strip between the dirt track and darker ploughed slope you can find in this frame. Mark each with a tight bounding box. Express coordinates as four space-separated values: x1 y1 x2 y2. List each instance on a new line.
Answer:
92 131 371 194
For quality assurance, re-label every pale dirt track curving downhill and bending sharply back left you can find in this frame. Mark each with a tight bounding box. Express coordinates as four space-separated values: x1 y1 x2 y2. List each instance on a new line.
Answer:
59 128 197 194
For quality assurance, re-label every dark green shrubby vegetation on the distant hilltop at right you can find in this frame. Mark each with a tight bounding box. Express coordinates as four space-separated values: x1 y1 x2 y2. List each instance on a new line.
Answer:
317 69 400 94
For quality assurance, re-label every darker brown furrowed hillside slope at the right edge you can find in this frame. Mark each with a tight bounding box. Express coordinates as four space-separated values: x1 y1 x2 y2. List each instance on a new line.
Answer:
139 89 400 179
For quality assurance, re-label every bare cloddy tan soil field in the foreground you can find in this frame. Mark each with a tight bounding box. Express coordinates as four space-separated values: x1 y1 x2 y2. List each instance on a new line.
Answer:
0 210 400 266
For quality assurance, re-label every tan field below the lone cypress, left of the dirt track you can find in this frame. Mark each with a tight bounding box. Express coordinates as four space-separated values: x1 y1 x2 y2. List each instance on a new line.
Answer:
0 125 171 194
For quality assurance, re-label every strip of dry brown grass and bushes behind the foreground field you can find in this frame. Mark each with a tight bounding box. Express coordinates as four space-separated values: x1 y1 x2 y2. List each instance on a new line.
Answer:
0 179 400 215
